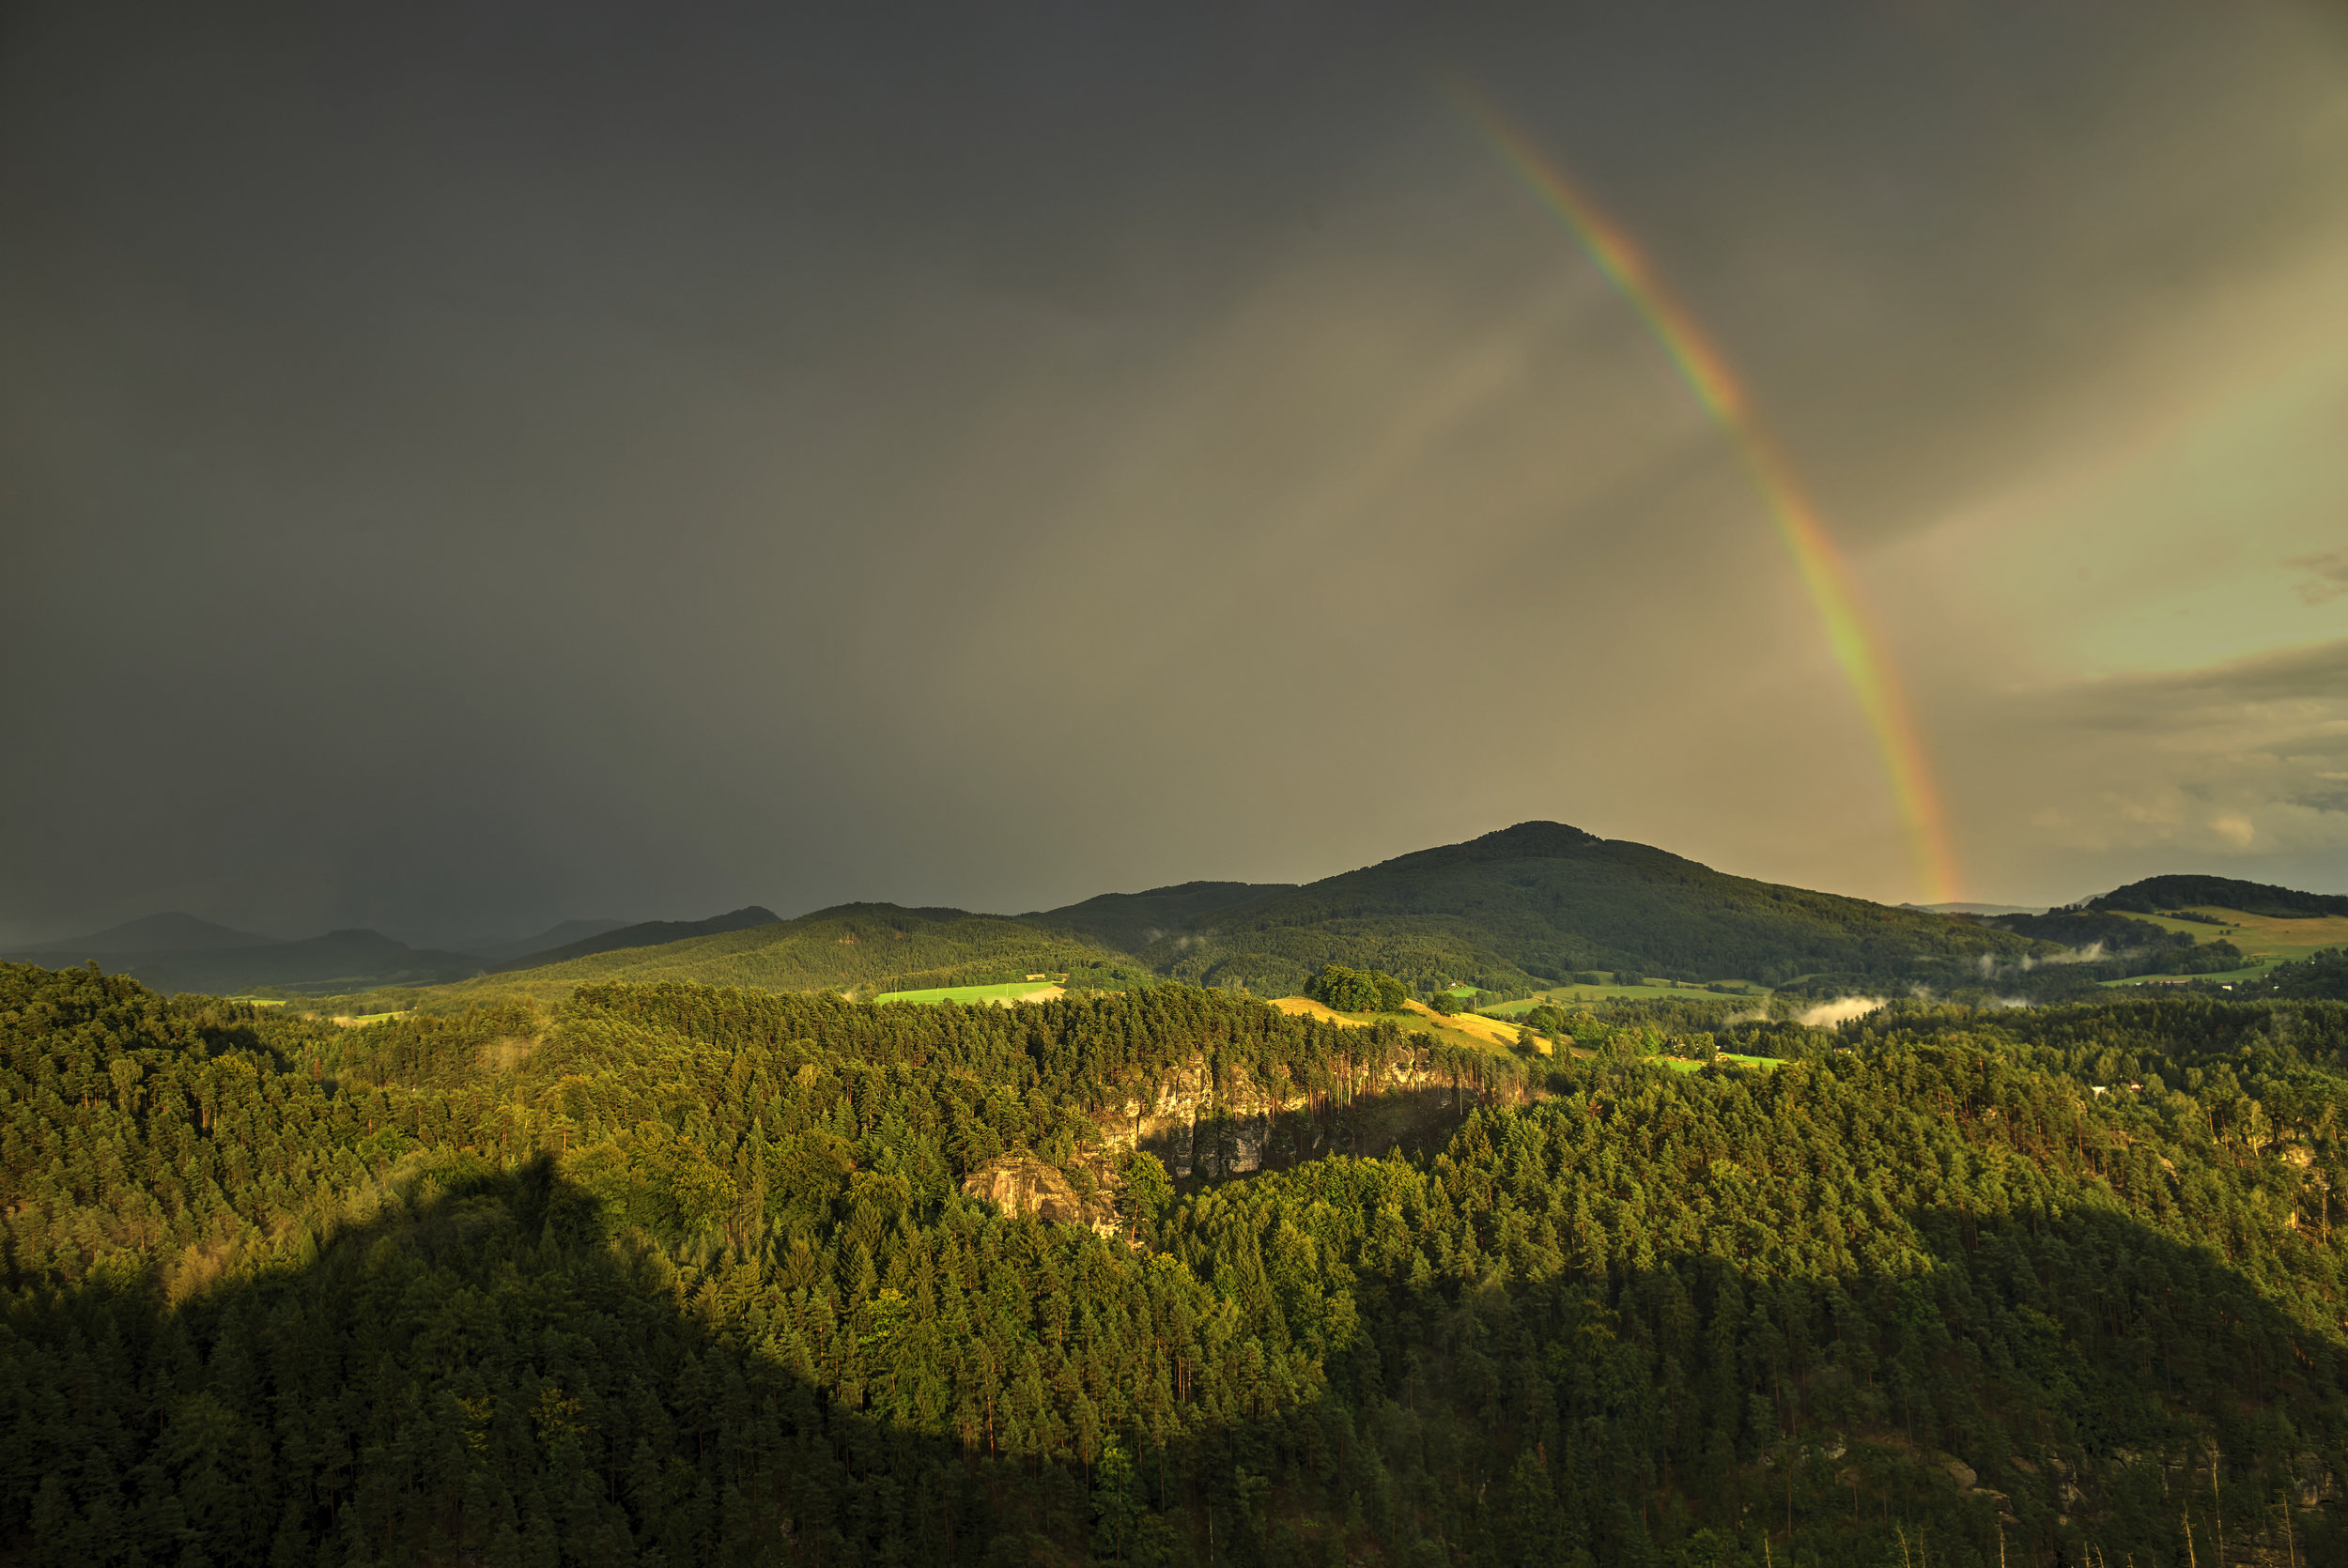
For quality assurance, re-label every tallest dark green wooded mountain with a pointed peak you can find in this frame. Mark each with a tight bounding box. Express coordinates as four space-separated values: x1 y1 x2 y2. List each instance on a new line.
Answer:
1141 822 2038 995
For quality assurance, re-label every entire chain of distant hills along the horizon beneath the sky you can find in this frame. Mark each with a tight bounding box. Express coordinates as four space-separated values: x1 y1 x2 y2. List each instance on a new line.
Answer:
59 822 2348 998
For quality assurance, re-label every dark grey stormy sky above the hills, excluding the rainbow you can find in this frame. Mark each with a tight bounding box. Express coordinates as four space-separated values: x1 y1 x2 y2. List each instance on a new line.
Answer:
0 0 2348 939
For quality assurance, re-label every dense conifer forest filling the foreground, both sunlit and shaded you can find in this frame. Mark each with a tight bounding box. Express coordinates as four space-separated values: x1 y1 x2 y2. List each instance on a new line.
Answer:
0 965 2348 1568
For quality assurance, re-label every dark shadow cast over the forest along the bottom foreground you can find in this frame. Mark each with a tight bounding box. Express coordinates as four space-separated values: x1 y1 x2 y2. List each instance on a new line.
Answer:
0 1160 2348 1568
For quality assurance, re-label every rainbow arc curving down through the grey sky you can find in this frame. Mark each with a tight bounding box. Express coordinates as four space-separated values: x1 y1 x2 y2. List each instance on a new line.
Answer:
1446 80 1961 904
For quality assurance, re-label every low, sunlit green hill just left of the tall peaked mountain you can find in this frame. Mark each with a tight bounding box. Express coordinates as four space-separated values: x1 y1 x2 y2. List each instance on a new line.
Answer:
463 904 1132 995
